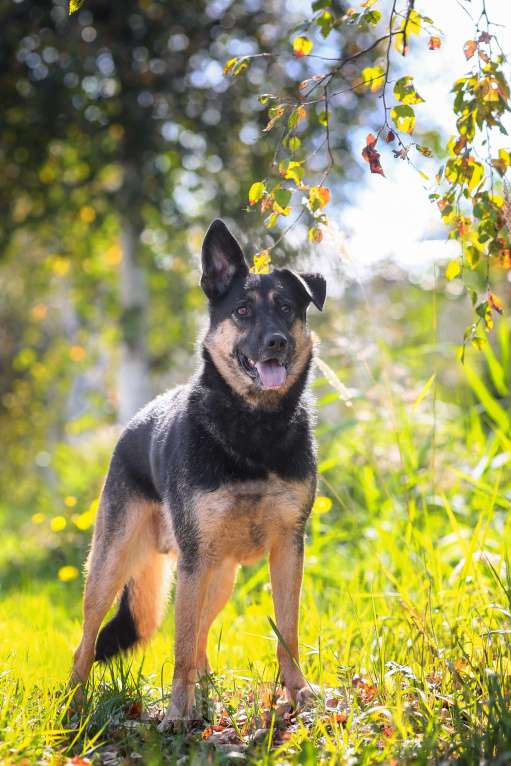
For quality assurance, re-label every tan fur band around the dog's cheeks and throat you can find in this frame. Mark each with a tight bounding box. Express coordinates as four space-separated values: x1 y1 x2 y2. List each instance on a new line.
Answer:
204 319 313 408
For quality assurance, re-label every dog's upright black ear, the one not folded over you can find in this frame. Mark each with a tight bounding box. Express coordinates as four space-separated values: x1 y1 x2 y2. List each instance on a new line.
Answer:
201 218 248 299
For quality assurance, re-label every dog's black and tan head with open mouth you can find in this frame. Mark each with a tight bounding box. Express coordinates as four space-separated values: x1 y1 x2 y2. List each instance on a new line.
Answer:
201 220 326 403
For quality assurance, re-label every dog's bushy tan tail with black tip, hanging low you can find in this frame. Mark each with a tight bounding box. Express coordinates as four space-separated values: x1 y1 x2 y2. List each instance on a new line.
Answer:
95 552 171 662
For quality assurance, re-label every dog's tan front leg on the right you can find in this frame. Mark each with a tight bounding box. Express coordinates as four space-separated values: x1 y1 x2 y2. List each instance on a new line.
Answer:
270 534 314 704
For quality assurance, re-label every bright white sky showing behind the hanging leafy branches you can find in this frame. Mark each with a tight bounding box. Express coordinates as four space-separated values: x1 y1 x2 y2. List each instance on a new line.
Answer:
292 0 511 278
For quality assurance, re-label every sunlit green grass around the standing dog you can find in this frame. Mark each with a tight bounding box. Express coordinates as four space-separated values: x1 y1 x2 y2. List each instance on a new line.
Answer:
0 306 511 764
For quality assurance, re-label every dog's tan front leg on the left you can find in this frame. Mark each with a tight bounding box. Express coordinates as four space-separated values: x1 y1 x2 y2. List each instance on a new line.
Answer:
159 561 211 731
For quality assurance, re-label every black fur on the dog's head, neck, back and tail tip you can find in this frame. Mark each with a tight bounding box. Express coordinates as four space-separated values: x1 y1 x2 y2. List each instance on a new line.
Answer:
96 221 325 659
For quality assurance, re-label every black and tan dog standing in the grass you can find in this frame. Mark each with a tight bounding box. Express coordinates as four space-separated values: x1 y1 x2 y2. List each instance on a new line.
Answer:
73 221 326 728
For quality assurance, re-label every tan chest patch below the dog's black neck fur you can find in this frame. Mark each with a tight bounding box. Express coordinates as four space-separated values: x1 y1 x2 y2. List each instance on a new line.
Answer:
194 475 313 563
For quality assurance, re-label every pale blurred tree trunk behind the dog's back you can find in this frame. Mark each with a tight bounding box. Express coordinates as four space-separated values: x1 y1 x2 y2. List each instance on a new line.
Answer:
118 214 151 425
